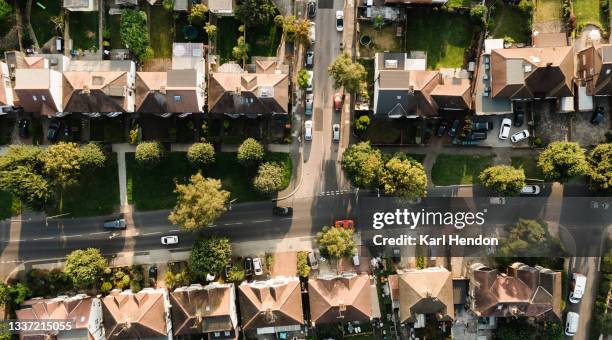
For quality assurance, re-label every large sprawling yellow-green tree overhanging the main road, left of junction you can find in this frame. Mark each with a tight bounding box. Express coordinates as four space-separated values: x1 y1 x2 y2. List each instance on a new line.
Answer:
168 172 230 230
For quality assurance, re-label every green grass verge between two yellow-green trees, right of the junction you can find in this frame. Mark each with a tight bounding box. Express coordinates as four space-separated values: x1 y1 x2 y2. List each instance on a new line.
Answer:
431 154 493 185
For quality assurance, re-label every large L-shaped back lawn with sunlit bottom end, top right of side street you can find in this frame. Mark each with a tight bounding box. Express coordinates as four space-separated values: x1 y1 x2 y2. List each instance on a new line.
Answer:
406 9 474 69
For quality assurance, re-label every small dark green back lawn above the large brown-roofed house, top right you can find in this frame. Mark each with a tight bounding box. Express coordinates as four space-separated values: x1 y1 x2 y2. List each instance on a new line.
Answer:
492 1 531 43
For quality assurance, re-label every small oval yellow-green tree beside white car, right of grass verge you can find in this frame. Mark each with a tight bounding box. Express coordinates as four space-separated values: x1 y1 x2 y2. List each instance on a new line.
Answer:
479 165 525 196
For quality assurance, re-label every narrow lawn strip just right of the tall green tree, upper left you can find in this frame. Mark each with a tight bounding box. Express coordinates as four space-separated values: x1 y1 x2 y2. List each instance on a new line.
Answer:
149 6 174 58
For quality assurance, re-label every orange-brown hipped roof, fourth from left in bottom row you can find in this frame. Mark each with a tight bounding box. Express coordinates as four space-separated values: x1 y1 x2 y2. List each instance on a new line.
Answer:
238 277 304 330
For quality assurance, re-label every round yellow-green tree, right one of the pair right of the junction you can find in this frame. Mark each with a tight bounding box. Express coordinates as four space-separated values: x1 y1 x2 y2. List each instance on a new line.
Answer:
380 157 427 198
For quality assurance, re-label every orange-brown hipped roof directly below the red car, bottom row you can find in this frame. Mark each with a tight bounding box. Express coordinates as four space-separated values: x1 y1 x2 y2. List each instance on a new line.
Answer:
308 274 373 324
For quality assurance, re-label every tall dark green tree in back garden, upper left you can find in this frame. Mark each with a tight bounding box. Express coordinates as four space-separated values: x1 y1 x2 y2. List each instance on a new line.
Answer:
119 9 150 58
